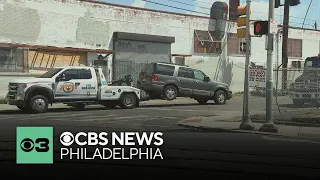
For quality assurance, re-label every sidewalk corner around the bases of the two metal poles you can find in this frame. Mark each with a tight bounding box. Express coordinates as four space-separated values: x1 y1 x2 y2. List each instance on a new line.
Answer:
178 113 320 139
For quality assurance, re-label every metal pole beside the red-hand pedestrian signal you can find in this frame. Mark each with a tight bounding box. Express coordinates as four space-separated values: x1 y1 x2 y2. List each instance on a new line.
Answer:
260 0 278 133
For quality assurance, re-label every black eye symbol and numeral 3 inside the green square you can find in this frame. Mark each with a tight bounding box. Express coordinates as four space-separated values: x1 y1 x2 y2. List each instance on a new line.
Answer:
20 138 49 152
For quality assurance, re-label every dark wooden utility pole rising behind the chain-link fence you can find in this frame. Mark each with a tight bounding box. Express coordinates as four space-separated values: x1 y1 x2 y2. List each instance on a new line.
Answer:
282 0 290 90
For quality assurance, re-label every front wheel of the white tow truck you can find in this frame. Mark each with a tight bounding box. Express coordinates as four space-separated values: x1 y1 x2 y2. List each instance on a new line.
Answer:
27 95 49 113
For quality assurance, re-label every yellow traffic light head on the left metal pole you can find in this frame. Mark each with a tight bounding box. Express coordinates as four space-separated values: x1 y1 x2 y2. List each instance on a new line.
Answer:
237 6 251 38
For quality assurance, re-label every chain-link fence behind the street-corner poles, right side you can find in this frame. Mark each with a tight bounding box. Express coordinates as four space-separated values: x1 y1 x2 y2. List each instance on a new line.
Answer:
249 67 320 123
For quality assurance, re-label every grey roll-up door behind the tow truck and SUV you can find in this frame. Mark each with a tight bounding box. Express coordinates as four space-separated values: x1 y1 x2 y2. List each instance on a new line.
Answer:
112 39 171 86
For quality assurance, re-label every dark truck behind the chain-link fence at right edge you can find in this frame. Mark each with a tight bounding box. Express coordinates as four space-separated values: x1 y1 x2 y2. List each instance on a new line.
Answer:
289 55 320 105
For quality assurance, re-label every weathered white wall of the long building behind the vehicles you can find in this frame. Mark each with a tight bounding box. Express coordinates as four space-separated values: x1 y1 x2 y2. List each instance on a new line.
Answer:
0 0 320 96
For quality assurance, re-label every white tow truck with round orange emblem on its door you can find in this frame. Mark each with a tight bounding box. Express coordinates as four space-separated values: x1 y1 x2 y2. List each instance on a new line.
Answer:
7 66 140 113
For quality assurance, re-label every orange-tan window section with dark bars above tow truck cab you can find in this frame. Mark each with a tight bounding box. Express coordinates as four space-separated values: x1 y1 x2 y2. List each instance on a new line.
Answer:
28 51 87 70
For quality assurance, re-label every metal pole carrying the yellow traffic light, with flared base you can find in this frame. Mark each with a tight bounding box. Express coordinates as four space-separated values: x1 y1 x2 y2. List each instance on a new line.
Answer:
240 0 254 130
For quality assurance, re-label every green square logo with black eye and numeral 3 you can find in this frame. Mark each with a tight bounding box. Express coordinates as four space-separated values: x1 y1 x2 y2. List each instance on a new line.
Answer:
16 127 53 164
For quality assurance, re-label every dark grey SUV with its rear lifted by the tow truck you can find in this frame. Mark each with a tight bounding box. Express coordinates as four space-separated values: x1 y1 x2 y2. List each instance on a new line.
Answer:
137 63 232 104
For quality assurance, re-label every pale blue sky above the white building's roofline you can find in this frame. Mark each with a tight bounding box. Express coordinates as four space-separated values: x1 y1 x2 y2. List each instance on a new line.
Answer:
100 0 320 29
